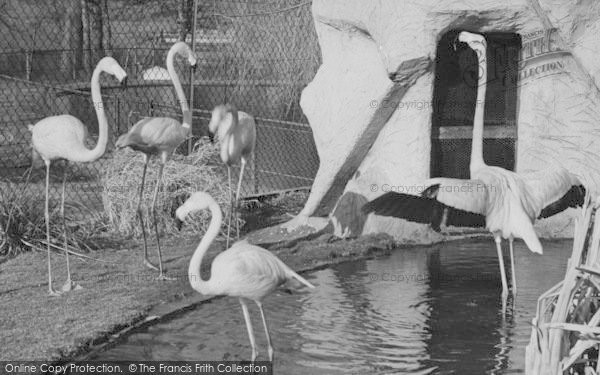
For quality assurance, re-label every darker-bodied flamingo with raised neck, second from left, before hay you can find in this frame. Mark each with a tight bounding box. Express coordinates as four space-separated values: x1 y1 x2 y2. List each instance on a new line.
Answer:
116 42 196 280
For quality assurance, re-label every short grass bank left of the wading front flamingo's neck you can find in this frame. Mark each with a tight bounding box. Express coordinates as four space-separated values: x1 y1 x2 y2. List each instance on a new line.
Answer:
0 236 199 360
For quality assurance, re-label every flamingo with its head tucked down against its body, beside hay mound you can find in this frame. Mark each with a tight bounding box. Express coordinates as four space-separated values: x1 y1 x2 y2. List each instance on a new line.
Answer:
208 104 256 247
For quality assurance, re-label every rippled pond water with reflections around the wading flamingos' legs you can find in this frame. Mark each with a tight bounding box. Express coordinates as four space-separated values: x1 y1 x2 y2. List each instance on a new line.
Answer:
90 238 572 374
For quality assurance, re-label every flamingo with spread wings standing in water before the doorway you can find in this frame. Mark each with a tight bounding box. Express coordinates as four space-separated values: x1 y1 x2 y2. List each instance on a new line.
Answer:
363 31 585 305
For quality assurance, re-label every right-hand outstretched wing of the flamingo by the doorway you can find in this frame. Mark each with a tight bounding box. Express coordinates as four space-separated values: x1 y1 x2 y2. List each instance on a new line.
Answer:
522 167 586 219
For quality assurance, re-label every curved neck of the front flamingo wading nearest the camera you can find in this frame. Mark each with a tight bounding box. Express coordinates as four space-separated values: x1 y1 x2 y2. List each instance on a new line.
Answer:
188 202 223 295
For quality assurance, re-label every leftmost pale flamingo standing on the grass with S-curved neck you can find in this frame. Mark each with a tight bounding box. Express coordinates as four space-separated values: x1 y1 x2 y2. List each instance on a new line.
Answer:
29 57 127 296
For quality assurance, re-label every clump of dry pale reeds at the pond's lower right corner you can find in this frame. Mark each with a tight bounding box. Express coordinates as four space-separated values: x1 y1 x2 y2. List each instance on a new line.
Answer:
525 196 600 375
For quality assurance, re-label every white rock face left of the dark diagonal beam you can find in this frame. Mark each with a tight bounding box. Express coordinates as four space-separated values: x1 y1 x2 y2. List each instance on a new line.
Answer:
300 10 391 219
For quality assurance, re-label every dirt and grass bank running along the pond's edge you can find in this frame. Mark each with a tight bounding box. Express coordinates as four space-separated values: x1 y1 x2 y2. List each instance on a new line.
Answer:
0 194 393 361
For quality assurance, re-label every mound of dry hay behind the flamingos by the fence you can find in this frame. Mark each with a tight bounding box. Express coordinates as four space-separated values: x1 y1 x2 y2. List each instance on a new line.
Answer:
102 139 242 237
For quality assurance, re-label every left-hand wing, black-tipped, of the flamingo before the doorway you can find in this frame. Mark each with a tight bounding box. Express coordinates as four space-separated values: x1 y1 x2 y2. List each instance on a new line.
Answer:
363 178 487 230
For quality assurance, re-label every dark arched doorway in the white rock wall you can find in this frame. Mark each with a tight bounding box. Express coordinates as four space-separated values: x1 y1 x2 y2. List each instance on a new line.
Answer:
431 30 521 178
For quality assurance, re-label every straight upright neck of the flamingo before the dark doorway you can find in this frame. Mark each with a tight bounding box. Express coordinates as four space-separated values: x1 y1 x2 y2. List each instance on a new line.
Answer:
469 42 487 177
